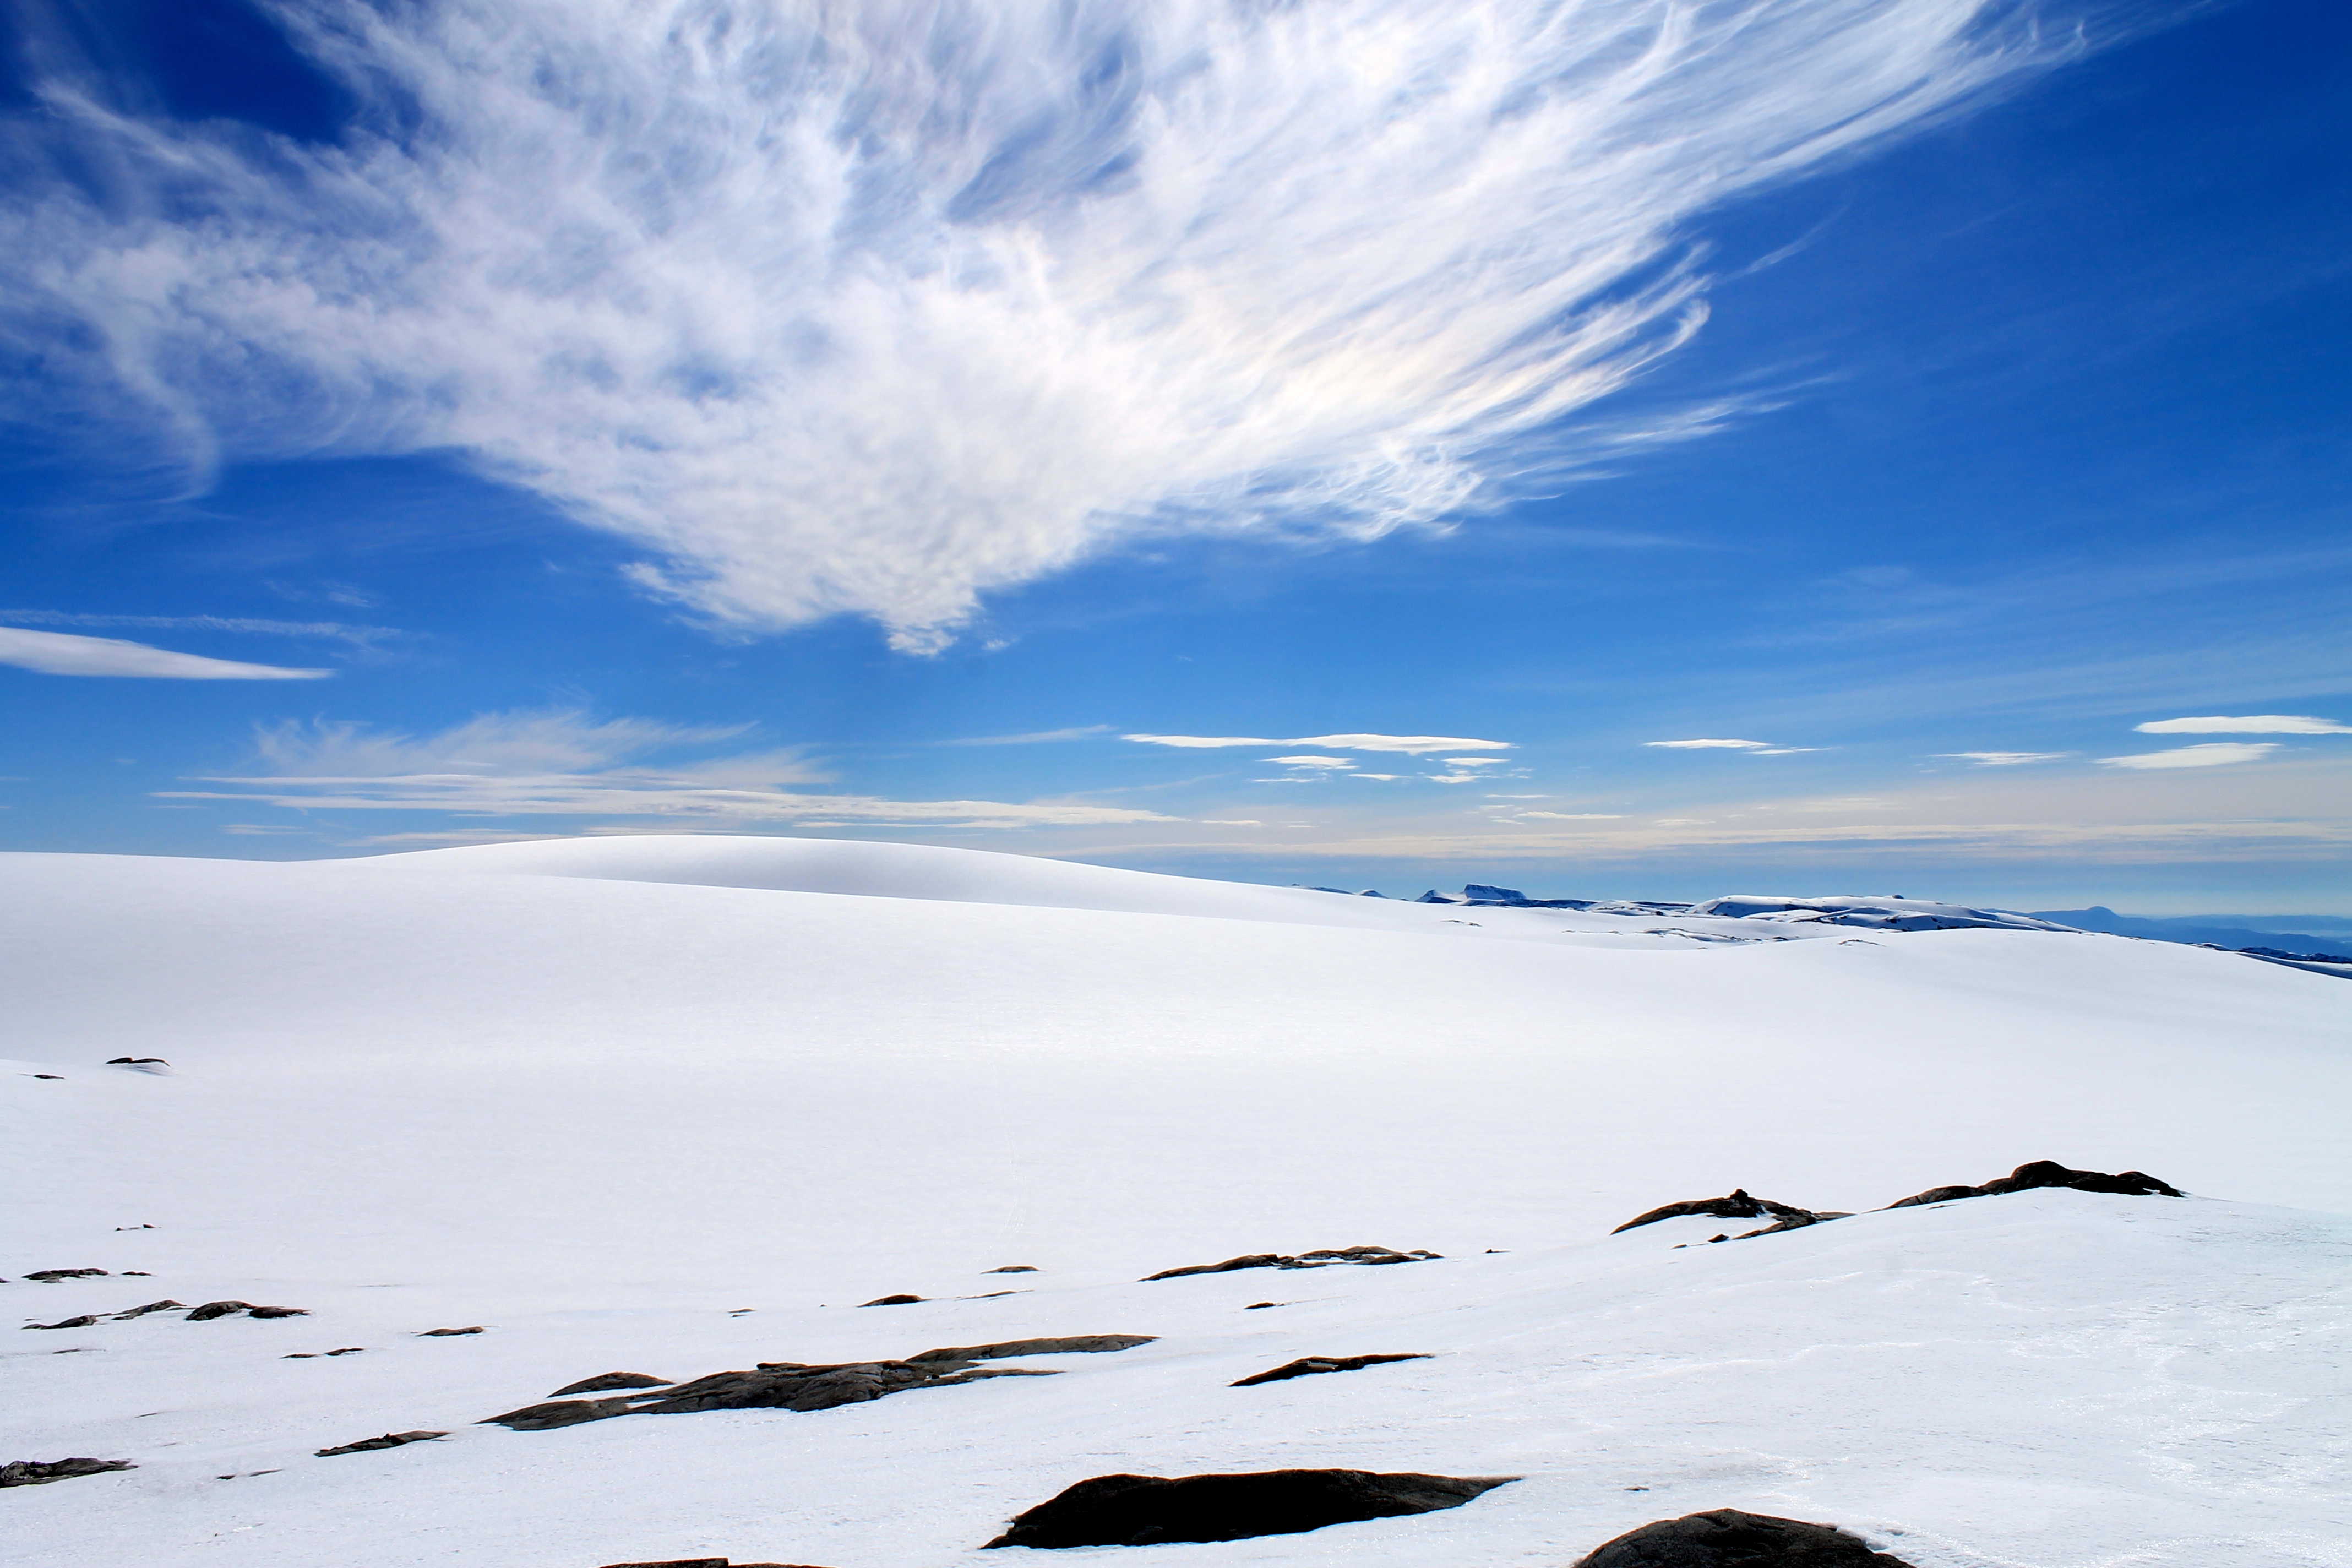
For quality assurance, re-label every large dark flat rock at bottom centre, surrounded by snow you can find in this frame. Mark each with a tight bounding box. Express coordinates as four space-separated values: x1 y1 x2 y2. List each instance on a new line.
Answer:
988 1469 1517 1547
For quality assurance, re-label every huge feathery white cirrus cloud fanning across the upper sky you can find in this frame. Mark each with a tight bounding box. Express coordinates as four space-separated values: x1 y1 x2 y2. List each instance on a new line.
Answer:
0 0 2084 651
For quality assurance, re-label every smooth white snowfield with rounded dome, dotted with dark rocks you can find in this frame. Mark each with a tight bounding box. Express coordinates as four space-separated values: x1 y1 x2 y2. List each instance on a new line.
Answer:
0 839 2352 1568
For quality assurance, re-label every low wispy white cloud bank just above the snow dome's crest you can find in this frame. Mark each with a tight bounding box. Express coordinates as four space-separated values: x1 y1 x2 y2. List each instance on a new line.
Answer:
157 710 1178 842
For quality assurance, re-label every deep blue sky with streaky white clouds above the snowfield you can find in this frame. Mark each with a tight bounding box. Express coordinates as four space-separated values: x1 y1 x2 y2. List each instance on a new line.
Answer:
0 0 2352 912
